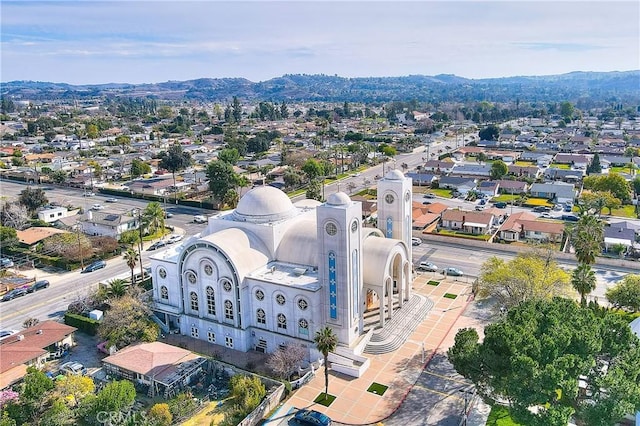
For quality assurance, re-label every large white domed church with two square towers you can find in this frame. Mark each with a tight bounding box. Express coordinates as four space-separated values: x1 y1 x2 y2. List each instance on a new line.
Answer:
151 170 424 372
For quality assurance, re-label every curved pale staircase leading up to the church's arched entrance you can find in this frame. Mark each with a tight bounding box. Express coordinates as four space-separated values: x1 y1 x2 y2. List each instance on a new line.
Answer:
364 294 433 355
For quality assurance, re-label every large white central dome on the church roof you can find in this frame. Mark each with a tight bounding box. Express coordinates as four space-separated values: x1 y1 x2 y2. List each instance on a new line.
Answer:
233 186 297 223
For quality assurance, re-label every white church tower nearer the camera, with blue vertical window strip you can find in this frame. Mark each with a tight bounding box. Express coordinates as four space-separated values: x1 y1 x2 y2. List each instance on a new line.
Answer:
316 192 363 346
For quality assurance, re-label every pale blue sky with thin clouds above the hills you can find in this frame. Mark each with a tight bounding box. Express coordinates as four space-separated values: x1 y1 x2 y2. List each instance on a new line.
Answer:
0 0 640 84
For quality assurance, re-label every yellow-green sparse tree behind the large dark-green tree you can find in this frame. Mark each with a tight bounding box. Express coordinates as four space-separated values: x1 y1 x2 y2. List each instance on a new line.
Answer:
478 250 570 309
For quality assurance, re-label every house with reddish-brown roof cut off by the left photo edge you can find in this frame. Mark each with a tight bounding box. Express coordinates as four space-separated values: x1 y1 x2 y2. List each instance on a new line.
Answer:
0 320 76 389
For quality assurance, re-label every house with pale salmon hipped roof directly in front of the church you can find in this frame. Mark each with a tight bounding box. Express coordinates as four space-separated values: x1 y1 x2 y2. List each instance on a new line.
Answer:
102 342 207 398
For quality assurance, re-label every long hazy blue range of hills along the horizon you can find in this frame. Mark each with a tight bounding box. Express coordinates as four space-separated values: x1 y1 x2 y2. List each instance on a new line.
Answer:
1 70 640 104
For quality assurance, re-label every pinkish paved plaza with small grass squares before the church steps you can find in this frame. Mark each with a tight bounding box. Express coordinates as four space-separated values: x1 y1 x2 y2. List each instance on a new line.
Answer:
274 274 488 425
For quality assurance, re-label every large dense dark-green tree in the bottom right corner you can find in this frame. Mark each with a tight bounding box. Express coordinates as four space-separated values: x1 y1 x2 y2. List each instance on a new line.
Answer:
448 298 640 426
